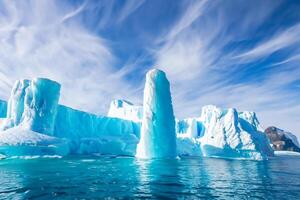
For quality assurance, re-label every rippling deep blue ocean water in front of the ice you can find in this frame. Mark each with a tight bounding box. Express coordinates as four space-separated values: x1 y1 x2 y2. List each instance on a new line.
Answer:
0 156 300 200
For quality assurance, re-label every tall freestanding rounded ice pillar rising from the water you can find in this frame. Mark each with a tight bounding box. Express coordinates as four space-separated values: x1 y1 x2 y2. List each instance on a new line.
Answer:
136 69 177 159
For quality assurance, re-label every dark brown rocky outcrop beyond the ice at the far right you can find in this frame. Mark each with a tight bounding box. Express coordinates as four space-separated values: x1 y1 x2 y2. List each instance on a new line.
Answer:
265 126 300 152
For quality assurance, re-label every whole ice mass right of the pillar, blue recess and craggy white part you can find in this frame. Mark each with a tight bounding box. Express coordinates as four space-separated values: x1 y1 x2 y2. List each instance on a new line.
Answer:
177 105 274 160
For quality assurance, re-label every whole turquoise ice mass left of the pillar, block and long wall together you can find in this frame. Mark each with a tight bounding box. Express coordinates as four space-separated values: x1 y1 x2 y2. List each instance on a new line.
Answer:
0 78 140 156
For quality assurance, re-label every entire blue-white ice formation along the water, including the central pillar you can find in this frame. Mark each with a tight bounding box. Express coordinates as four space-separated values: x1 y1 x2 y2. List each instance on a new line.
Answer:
0 70 273 159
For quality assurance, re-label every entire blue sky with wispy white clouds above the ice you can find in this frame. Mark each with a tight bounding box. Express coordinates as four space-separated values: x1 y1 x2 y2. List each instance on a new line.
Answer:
0 0 300 137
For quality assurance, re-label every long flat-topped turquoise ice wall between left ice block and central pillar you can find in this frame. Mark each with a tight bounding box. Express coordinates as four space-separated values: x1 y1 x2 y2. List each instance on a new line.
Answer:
54 105 140 156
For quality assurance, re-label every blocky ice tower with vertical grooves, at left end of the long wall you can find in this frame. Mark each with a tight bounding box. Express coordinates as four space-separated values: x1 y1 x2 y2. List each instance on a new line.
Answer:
1 78 60 135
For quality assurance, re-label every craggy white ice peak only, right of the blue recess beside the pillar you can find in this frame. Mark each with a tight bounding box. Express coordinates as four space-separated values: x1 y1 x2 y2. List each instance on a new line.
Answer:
199 105 274 160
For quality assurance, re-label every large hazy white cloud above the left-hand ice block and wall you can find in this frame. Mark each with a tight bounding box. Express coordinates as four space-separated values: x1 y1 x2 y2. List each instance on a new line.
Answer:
0 1 139 113
